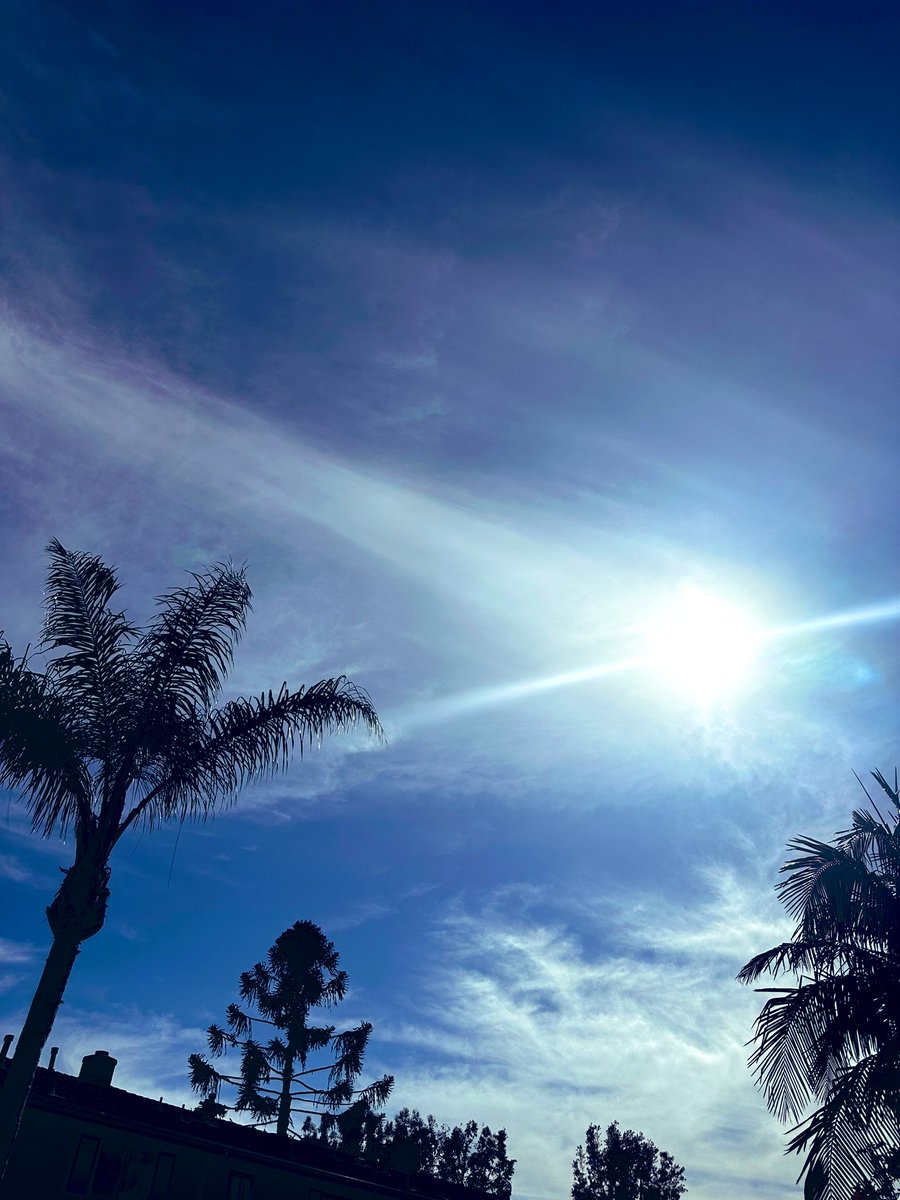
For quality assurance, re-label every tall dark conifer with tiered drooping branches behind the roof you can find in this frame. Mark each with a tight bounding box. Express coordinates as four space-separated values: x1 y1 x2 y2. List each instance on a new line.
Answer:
188 920 394 1136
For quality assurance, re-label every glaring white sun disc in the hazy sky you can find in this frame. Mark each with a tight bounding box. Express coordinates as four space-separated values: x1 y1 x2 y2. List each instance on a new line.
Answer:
647 583 760 702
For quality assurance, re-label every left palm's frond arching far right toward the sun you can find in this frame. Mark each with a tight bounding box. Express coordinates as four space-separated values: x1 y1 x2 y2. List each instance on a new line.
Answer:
119 676 382 835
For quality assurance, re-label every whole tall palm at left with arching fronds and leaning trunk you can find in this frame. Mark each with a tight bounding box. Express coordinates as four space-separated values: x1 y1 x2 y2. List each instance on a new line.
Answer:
0 540 382 1172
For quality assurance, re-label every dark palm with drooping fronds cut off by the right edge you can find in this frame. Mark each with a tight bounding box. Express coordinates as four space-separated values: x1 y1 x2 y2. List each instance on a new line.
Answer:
738 770 900 1200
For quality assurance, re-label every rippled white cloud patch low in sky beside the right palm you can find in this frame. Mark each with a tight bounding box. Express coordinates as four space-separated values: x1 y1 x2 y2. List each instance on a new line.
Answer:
378 871 796 1200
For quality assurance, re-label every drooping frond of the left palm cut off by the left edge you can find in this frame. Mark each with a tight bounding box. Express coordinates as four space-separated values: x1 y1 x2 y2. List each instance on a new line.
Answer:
0 641 91 836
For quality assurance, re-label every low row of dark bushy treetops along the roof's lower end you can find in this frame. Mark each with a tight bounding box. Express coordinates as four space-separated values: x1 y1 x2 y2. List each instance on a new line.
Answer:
314 1102 516 1196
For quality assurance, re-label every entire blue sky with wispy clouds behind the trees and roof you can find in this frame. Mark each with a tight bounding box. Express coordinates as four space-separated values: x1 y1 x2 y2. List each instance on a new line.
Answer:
0 0 900 1200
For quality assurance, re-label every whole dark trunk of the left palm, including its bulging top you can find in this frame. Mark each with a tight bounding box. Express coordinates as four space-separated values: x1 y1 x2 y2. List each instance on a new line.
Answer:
0 848 109 1194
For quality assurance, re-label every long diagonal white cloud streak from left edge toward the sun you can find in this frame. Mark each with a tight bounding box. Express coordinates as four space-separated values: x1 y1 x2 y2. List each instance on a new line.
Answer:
0 324 628 657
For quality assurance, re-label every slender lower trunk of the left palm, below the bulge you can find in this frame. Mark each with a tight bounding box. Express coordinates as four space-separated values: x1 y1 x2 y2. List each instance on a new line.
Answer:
0 936 80 1188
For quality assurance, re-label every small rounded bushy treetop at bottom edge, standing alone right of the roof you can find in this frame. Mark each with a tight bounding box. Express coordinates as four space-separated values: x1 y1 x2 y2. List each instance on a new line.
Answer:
572 1121 688 1200
